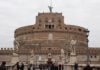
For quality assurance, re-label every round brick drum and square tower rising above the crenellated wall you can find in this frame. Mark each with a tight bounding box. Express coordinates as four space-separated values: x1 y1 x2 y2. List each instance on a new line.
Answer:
15 13 88 53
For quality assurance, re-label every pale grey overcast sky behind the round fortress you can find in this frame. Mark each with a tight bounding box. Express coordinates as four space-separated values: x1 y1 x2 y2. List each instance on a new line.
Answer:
0 0 100 47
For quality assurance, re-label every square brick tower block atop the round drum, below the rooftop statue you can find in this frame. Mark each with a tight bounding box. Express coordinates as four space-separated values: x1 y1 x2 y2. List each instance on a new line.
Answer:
35 12 64 30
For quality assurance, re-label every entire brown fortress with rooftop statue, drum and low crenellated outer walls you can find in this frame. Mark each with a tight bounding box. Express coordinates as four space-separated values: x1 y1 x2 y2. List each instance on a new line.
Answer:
0 7 100 65
